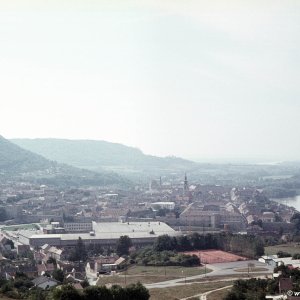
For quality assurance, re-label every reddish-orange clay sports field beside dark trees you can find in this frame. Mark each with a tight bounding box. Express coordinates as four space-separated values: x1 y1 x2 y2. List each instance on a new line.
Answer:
184 250 247 264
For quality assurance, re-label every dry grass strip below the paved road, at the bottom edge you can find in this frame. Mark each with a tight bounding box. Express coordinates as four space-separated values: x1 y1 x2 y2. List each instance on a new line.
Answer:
149 281 232 300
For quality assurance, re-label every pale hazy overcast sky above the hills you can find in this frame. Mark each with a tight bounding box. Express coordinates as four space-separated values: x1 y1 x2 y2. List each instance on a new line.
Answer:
0 0 300 161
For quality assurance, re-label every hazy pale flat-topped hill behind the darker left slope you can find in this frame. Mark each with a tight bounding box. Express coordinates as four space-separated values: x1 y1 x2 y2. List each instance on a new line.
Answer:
11 139 196 177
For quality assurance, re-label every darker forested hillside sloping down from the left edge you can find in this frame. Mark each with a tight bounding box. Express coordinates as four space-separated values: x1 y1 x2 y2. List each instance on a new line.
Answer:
0 136 129 186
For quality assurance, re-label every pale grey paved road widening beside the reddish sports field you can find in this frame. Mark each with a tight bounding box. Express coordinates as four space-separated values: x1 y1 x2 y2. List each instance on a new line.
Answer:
145 260 273 289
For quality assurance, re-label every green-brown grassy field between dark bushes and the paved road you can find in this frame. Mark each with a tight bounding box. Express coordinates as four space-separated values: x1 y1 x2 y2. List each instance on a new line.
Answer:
98 266 211 286
